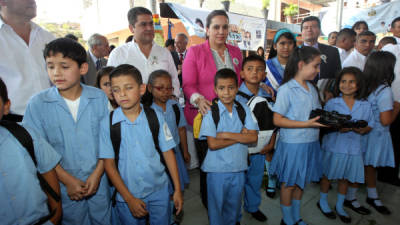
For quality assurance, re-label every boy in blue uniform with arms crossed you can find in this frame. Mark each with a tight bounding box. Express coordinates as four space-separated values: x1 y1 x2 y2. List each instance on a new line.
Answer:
200 69 258 225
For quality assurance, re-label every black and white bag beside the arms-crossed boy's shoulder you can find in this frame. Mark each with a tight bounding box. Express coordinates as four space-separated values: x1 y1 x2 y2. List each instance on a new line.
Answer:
238 91 275 154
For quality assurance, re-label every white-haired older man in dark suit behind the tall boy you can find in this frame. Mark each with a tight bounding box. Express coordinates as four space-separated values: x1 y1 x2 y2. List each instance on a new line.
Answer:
82 34 110 86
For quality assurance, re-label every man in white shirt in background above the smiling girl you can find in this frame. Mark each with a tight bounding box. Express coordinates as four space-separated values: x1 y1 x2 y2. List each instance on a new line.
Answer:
342 30 376 71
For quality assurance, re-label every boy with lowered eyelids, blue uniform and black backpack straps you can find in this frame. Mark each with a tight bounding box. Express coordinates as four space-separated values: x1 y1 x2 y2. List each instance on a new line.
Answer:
100 64 183 225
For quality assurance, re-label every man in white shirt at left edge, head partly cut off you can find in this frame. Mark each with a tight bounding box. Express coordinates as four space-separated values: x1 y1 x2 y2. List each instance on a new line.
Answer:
0 0 54 121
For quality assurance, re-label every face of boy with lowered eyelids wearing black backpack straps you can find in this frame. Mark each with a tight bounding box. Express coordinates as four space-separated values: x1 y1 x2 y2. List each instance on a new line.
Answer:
111 75 146 110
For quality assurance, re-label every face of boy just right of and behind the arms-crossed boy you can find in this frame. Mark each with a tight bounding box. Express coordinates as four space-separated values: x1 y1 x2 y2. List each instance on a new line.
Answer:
240 61 265 84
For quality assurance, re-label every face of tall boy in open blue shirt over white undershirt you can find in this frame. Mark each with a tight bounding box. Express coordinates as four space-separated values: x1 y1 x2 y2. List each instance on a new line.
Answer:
46 53 88 92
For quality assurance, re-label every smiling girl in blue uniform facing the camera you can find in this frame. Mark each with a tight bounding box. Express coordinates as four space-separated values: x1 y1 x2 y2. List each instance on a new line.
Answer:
317 67 374 223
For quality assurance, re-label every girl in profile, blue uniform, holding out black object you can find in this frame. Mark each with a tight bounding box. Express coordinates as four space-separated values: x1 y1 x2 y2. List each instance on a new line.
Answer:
269 46 322 225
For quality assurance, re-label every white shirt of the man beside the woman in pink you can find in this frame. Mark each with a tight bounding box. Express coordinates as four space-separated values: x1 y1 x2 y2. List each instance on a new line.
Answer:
107 41 180 96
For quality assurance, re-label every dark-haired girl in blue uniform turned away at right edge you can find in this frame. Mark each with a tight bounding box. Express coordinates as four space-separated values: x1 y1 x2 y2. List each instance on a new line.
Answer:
356 51 400 214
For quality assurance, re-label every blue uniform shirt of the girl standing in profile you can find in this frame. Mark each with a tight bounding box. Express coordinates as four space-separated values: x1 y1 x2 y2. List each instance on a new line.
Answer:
272 79 321 143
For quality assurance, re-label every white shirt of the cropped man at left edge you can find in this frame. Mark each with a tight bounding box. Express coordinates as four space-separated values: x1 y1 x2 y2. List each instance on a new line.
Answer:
0 18 54 115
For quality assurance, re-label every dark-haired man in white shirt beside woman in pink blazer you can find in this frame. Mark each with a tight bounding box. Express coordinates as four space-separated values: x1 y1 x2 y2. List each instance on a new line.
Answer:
107 7 180 97
